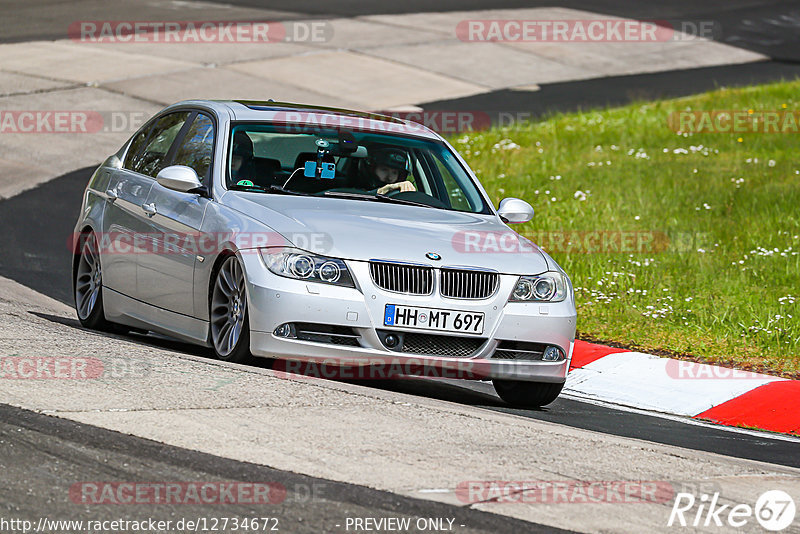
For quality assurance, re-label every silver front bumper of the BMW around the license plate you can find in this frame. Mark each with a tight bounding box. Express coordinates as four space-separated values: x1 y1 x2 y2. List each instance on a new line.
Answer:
240 250 576 383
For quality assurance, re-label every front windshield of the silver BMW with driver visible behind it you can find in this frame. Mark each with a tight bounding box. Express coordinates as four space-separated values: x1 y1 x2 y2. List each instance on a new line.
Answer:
227 123 491 213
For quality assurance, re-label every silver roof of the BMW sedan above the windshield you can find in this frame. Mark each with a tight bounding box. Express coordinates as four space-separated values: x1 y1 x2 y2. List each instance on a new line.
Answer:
170 100 441 139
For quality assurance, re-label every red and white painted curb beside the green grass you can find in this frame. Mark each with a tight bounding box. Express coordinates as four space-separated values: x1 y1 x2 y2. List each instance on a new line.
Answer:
564 340 800 435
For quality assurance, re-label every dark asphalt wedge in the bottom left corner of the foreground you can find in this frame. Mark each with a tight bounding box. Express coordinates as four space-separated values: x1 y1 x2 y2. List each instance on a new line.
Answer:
0 405 565 534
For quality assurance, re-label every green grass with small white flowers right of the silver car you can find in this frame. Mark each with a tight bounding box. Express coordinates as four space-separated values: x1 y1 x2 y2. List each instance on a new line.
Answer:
452 81 800 376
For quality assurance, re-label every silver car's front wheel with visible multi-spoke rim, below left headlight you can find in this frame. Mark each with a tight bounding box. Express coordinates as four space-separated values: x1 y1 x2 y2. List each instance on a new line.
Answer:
209 256 253 363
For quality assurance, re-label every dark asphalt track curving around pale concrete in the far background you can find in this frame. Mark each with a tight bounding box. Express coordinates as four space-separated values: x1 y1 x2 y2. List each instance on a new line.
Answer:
0 0 800 118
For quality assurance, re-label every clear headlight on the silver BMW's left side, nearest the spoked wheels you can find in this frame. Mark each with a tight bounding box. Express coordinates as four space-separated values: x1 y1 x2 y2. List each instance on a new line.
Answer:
259 248 356 287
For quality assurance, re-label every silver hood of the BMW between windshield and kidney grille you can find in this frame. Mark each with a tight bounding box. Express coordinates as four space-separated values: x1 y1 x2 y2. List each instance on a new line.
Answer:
222 191 548 274
